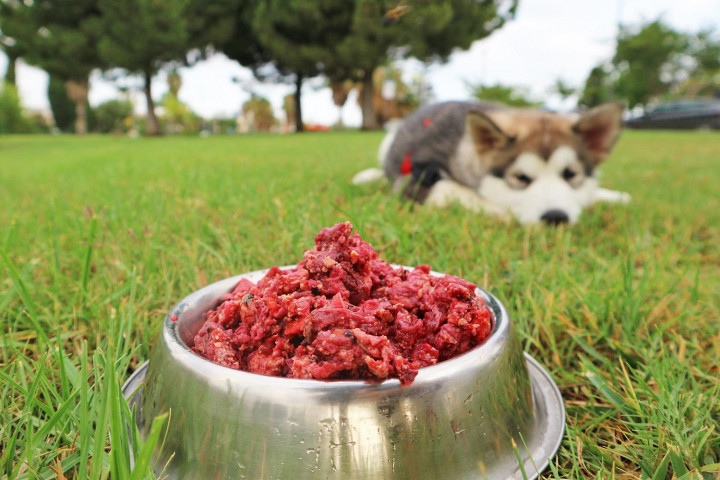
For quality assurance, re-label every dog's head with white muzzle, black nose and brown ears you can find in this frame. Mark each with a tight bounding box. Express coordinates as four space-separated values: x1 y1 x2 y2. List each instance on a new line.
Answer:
467 103 623 224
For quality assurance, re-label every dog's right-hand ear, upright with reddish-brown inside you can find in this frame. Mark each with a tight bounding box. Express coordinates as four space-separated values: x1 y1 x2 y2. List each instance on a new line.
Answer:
573 102 624 163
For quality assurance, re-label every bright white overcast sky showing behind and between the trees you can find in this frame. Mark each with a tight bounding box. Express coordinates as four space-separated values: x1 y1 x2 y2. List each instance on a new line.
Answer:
0 0 720 126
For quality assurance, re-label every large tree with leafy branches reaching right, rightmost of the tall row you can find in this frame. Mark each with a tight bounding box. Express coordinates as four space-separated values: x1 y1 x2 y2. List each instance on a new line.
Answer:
326 0 517 129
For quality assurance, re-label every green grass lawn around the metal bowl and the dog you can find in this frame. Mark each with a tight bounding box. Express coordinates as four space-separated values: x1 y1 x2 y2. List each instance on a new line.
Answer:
0 131 720 479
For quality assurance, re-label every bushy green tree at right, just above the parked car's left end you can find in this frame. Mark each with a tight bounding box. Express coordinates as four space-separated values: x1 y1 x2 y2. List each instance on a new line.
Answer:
612 20 687 108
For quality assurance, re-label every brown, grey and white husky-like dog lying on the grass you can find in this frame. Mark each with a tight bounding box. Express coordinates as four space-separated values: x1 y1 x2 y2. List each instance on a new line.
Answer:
353 102 630 225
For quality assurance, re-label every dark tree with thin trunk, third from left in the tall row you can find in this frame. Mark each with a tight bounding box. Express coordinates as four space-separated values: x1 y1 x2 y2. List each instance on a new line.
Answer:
252 0 352 132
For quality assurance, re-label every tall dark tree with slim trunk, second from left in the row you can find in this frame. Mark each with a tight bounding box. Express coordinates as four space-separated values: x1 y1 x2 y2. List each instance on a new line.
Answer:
98 0 188 135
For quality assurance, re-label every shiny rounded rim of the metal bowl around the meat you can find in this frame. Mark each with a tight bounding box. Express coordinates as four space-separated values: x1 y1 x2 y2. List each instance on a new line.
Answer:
160 264 511 392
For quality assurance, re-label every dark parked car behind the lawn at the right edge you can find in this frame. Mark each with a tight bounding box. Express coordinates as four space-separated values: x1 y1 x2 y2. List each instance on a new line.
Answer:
625 99 720 129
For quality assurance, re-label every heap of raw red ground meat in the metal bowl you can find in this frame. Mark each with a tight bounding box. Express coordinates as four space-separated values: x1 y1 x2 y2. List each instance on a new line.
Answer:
192 222 492 385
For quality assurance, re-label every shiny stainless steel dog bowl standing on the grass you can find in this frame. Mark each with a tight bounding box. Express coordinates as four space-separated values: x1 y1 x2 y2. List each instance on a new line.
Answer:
123 270 565 480
